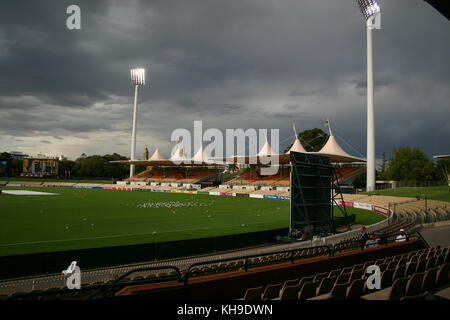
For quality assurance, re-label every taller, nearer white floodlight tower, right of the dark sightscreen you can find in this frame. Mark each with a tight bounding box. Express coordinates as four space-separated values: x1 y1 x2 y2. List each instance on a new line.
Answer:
356 0 380 191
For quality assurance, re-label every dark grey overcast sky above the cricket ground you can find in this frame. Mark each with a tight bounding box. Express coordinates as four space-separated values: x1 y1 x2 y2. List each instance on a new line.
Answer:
0 0 450 160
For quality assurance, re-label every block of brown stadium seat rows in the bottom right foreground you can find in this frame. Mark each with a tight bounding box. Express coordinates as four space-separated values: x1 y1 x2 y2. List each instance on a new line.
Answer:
240 248 450 300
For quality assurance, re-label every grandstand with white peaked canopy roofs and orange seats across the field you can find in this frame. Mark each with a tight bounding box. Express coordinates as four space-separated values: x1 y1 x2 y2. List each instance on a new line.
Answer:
117 126 365 193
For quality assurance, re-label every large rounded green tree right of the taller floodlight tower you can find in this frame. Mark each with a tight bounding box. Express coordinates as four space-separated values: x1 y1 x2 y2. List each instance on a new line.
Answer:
383 147 436 181
